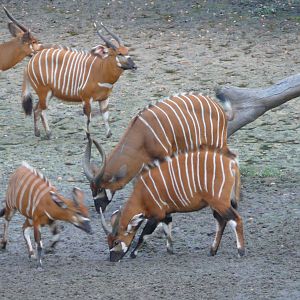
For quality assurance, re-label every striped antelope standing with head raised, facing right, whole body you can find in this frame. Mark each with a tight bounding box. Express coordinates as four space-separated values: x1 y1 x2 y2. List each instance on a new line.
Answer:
22 24 136 138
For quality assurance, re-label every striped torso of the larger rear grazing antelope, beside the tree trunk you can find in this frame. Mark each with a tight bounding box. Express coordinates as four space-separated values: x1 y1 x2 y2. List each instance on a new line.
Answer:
138 94 227 155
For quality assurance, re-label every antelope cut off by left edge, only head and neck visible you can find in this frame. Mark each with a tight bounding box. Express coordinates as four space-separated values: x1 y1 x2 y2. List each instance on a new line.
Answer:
0 7 41 71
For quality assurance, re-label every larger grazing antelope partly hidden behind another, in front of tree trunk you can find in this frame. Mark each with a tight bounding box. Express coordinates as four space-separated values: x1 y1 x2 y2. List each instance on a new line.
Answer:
83 94 230 253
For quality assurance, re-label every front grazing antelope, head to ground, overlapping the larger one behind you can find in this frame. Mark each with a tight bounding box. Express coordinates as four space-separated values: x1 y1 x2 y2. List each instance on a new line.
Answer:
101 148 245 261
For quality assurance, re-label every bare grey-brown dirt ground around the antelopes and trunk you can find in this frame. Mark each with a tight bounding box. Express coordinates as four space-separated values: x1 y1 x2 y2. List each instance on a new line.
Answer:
0 0 300 299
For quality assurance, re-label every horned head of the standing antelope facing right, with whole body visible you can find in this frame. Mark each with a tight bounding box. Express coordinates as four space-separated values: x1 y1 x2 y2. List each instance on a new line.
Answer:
94 23 137 70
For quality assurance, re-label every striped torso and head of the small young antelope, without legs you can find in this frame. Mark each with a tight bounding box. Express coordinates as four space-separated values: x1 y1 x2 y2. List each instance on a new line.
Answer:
6 162 89 227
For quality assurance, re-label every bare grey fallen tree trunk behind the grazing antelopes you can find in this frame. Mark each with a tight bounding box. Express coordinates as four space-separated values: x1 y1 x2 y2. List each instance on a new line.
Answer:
216 74 300 136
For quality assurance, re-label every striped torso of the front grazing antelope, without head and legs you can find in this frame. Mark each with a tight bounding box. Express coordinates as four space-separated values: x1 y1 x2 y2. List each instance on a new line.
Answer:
136 148 238 213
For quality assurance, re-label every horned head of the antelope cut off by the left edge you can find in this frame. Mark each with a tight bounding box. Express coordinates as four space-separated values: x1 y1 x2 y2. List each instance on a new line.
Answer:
3 7 41 56
